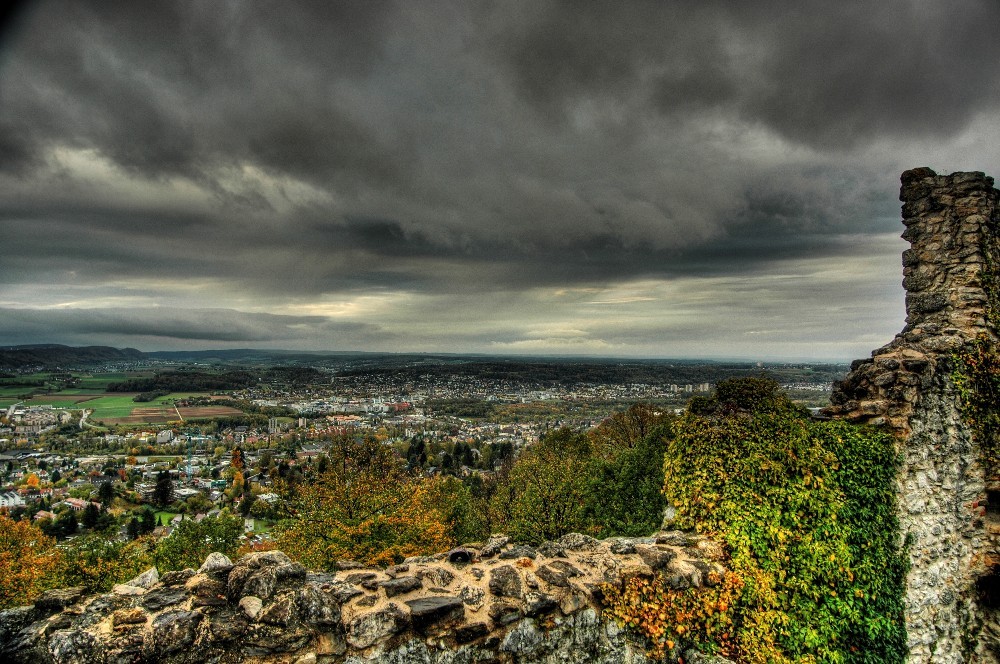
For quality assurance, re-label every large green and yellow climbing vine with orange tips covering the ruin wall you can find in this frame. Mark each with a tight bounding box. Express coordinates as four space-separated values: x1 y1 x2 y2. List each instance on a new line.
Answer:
606 382 906 663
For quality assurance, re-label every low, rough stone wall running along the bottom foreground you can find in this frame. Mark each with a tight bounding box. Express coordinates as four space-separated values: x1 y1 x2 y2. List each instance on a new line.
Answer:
0 532 725 664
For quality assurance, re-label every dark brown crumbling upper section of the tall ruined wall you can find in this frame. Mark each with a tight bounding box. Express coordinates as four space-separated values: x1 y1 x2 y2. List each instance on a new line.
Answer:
825 168 1000 435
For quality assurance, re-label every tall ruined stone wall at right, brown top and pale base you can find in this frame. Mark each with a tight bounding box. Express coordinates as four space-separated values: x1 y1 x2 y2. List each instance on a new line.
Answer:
827 168 1000 663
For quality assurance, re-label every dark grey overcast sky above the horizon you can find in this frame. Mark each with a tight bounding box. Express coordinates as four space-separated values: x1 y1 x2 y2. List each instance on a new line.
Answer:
0 0 1000 360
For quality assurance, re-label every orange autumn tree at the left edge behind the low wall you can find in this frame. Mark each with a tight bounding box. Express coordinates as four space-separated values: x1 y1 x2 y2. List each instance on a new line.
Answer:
0 513 62 609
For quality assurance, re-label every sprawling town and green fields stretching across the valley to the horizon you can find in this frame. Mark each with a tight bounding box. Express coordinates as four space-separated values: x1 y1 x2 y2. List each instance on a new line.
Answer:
0 347 847 542
